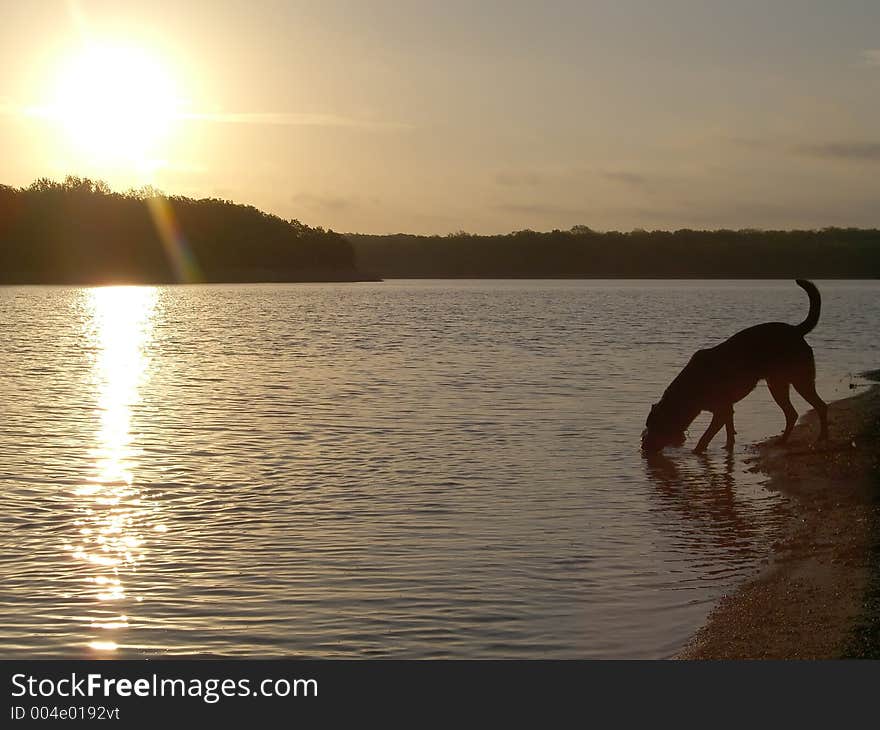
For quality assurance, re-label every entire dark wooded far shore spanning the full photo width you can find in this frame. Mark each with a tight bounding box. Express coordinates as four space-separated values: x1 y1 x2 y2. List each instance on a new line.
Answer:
0 177 880 284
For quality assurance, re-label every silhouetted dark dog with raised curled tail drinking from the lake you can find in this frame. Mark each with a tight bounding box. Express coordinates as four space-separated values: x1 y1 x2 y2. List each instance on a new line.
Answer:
642 279 828 454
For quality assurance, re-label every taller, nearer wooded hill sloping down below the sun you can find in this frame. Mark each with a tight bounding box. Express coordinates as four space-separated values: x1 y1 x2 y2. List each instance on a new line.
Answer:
0 177 363 284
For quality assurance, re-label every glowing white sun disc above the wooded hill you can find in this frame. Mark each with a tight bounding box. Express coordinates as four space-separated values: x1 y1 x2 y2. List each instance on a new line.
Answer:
48 44 180 169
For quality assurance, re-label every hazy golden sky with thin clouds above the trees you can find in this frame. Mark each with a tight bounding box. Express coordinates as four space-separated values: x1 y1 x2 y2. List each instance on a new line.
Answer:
0 0 880 234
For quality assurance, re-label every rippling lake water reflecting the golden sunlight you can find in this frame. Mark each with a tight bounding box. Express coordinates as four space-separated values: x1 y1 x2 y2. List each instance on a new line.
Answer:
0 281 880 658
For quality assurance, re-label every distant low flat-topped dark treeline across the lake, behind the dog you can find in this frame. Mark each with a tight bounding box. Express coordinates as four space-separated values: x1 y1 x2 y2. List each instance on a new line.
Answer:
347 226 880 279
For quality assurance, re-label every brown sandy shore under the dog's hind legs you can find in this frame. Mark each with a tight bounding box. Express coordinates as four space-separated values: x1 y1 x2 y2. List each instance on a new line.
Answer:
678 378 880 659
